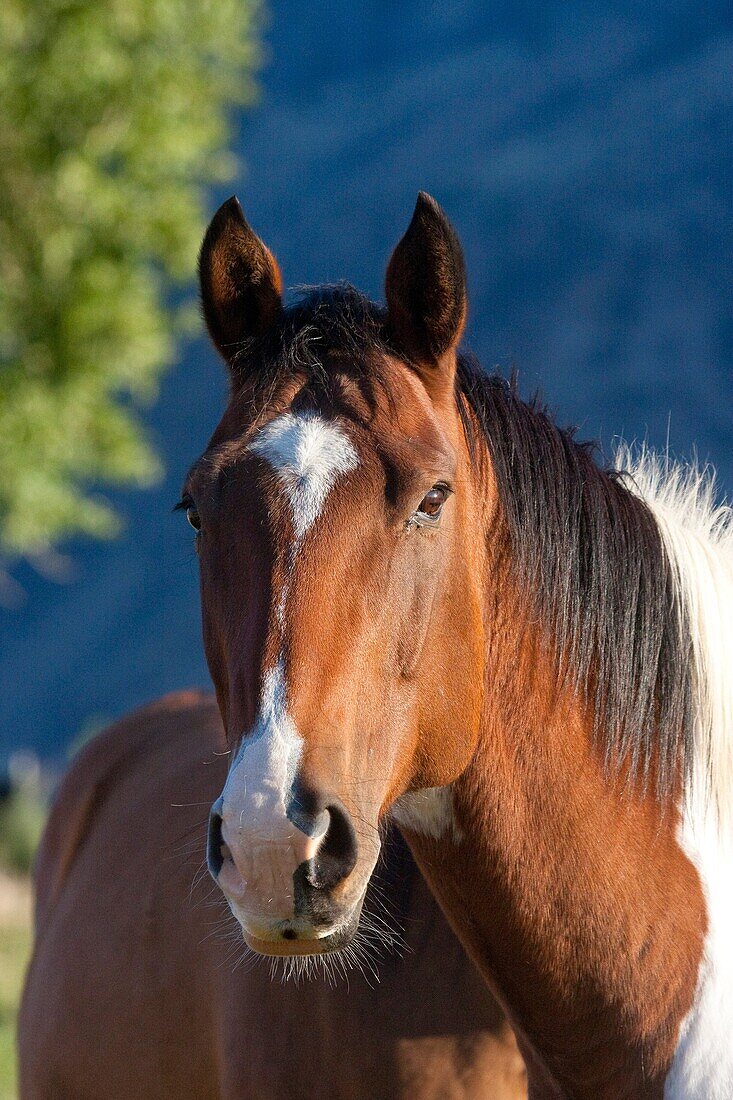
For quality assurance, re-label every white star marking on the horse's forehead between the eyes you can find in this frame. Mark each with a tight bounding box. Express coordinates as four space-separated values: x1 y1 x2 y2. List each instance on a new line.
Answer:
250 411 359 541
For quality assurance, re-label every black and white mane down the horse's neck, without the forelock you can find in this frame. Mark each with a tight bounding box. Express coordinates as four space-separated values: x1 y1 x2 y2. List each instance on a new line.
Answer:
457 356 733 814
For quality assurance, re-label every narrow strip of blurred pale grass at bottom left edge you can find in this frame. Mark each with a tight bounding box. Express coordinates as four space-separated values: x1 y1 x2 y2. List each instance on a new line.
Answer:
0 869 32 1100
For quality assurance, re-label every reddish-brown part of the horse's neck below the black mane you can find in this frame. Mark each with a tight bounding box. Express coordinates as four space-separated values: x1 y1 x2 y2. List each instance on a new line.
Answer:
411 541 705 1098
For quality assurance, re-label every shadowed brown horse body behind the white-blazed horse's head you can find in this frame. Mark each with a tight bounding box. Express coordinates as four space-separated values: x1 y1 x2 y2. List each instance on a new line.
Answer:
20 692 526 1100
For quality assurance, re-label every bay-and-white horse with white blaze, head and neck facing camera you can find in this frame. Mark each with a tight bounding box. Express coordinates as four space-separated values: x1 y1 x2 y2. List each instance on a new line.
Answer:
180 194 733 1100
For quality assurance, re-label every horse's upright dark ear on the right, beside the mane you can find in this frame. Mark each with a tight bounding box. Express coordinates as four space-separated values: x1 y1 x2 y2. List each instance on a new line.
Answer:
385 191 467 395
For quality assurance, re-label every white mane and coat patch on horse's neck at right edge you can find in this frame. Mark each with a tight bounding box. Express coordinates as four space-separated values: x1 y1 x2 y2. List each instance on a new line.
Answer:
616 450 733 1100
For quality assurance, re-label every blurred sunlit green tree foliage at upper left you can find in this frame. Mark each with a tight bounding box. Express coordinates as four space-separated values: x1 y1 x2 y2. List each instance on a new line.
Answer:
0 0 256 558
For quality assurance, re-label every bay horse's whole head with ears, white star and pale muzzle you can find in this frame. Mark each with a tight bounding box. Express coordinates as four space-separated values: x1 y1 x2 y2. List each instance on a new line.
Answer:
184 195 485 954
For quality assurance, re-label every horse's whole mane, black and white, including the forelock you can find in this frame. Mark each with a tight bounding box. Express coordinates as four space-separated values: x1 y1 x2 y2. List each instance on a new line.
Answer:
233 283 733 798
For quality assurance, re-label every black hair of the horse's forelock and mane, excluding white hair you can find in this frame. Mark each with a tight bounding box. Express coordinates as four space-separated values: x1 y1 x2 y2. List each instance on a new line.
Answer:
242 284 692 794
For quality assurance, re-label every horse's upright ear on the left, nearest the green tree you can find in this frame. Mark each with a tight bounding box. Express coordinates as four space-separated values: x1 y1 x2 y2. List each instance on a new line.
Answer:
198 195 283 364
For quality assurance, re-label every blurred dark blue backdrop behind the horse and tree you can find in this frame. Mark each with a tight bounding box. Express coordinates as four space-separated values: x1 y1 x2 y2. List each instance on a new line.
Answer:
0 0 733 760
